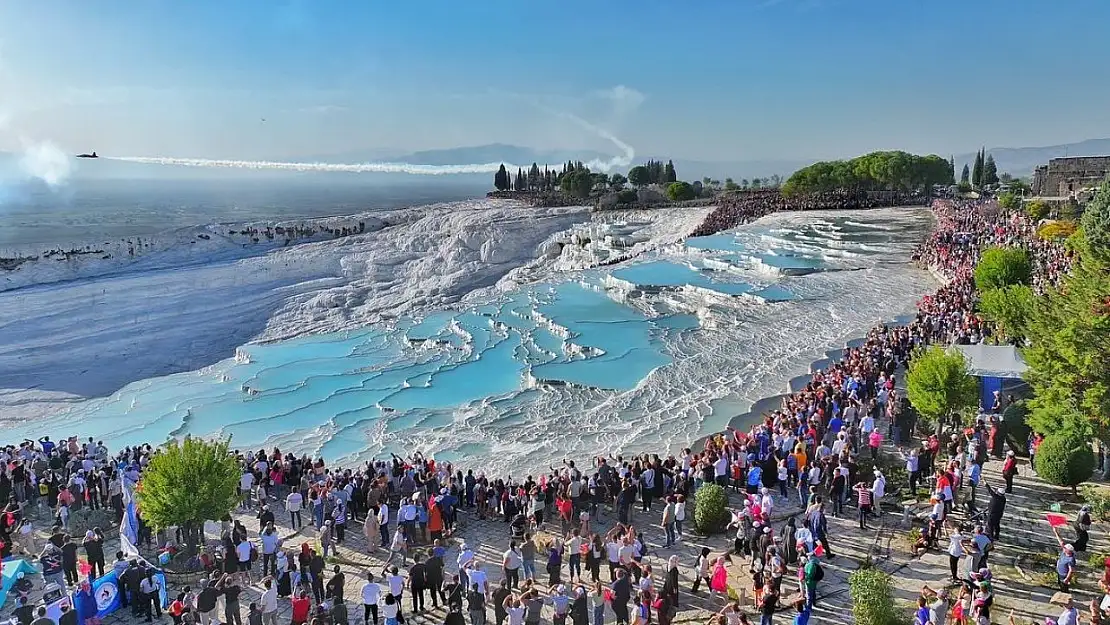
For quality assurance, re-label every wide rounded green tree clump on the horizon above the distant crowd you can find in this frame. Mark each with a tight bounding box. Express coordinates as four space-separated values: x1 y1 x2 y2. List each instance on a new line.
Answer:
783 152 951 195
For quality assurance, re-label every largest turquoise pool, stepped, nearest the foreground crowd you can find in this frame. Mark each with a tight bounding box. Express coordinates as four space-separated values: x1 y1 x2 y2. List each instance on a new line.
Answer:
13 282 697 457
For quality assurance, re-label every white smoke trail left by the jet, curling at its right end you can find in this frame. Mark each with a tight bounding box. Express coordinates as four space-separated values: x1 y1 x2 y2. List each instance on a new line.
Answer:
102 111 636 175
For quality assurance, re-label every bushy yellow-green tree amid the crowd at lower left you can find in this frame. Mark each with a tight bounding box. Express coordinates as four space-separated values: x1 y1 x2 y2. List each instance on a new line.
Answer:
135 437 240 554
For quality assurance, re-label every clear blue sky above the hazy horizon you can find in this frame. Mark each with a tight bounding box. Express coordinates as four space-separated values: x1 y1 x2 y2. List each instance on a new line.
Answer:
0 0 1110 161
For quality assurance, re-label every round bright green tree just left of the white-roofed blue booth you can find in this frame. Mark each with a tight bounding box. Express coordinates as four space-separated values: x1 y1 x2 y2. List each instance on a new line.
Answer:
906 346 979 433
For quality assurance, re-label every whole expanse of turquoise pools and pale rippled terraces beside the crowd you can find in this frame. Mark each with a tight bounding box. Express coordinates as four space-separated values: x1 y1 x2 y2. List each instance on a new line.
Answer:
10 207 925 471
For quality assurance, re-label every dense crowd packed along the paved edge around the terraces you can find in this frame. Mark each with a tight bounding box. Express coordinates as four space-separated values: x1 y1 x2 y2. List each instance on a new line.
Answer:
0 192 1089 625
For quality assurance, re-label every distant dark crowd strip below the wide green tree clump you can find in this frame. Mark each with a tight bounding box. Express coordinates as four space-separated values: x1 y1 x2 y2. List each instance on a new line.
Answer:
692 189 921 236
